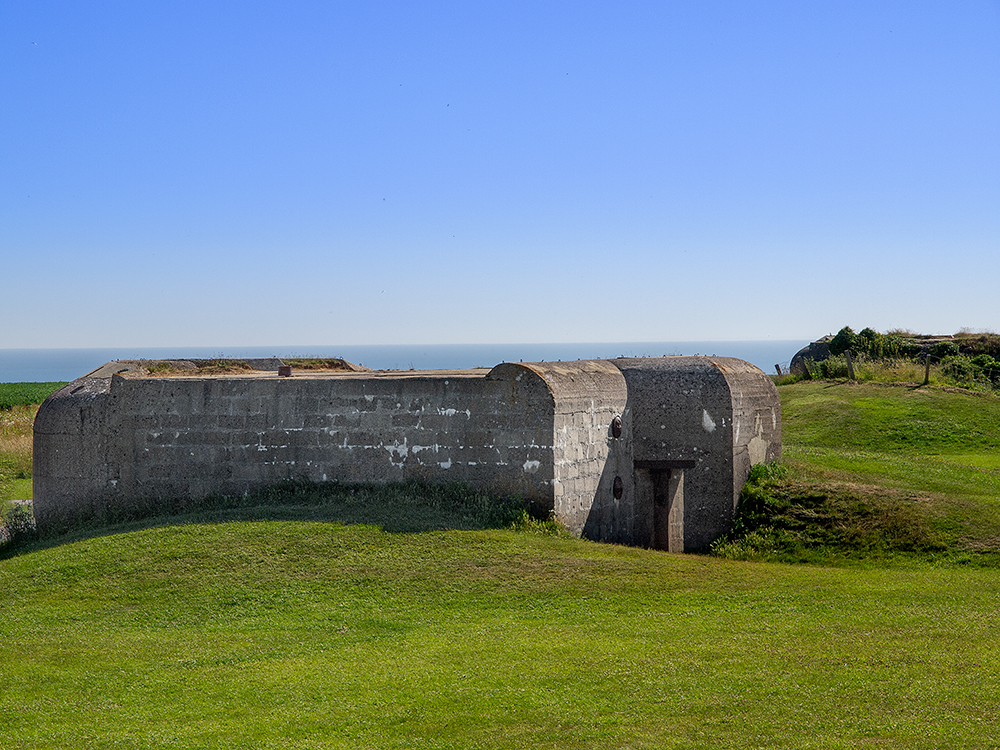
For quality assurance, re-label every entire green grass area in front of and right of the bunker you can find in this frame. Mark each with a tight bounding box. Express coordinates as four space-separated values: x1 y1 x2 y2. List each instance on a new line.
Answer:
0 382 1000 748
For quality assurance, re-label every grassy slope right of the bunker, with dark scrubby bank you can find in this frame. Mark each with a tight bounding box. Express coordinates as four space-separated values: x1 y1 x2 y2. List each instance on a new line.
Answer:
716 381 1000 565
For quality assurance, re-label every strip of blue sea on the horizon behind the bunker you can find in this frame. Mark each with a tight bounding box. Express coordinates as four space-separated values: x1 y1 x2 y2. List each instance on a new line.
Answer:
0 340 809 383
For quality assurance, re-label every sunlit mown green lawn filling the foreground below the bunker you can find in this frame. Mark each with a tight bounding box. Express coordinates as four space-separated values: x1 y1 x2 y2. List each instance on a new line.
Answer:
0 521 1000 748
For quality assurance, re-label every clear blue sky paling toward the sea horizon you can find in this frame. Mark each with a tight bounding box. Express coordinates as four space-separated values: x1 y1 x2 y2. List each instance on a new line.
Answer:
0 0 1000 348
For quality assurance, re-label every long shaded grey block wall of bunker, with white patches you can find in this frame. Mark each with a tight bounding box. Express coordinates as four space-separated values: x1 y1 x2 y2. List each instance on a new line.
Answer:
35 365 553 527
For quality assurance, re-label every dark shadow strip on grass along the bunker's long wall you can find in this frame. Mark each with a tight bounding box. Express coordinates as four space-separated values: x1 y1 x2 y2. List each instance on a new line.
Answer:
0 481 558 559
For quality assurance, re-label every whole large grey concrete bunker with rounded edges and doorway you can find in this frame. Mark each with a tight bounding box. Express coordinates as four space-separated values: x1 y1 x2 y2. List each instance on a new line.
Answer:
34 356 781 552
